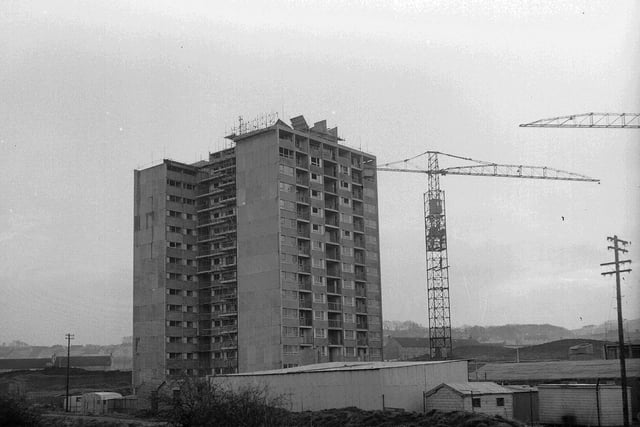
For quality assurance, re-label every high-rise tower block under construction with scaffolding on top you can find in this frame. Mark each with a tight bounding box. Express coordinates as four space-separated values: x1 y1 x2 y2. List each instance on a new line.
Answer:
133 116 382 387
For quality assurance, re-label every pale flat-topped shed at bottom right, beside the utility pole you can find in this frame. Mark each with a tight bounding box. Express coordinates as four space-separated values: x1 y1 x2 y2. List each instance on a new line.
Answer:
538 384 631 427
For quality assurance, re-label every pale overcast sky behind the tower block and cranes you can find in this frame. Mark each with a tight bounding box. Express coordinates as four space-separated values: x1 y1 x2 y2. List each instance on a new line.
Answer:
0 1 640 345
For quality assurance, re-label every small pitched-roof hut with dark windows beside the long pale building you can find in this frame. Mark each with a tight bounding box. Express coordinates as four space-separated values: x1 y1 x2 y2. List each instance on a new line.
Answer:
424 382 513 419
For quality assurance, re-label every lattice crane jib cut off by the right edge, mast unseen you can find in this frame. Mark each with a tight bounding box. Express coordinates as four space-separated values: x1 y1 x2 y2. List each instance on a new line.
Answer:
520 113 640 129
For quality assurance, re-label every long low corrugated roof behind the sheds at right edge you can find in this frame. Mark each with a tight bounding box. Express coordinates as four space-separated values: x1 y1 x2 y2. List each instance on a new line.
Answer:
470 359 640 381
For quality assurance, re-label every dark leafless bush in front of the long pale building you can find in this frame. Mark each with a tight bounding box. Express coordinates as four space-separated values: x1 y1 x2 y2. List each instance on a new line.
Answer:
161 378 288 427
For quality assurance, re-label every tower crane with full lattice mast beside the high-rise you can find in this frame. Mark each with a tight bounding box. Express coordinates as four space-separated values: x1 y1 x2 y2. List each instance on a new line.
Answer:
376 151 600 360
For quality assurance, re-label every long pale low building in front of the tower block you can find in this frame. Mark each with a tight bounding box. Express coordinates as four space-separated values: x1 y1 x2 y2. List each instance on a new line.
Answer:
210 361 467 412
